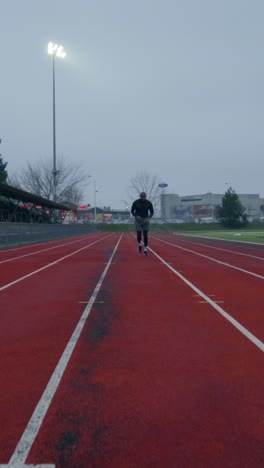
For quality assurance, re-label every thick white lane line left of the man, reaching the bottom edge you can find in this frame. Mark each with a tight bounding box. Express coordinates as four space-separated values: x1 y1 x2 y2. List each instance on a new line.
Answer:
5 234 123 468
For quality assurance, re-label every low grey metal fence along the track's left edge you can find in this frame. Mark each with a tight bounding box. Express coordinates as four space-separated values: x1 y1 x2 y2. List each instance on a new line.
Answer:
0 223 96 249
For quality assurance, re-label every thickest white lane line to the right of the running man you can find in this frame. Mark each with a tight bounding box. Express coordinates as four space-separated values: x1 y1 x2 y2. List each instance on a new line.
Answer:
149 249 264 351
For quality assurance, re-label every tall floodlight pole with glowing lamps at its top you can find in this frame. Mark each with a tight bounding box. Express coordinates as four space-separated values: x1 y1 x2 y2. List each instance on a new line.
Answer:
48 42 66 202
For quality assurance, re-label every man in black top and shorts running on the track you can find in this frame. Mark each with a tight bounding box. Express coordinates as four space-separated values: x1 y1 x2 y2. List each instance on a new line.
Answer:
131 192 154 257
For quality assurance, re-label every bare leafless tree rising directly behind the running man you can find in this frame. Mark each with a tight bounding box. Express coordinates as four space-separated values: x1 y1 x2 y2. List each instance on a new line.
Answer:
128 171 161 207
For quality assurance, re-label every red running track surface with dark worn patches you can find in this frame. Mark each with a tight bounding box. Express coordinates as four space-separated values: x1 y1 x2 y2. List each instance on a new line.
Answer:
0 234 264 468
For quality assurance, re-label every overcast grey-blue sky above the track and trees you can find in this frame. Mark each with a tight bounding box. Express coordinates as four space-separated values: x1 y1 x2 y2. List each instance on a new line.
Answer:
0 0 264 208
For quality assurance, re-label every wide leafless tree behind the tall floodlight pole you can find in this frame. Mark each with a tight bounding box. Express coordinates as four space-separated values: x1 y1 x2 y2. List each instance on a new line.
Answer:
10 156 88 204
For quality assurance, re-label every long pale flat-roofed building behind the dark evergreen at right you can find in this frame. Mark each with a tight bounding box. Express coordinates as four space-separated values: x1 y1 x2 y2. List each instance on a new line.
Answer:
161 192 264 222
